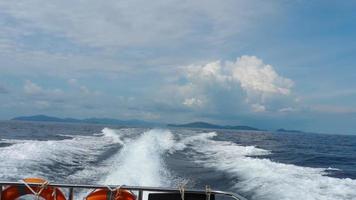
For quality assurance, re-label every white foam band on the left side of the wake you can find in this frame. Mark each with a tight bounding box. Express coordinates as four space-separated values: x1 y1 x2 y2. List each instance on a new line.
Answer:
0 129 124 182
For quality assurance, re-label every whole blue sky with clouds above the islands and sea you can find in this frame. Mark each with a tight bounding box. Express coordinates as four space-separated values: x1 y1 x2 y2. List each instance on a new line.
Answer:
0 0 356 134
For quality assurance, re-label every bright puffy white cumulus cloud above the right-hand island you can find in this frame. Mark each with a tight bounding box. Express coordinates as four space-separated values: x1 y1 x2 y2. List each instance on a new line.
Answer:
176 56 294 112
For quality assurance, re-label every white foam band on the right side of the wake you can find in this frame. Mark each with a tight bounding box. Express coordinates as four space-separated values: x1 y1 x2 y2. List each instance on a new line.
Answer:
189 133 356 200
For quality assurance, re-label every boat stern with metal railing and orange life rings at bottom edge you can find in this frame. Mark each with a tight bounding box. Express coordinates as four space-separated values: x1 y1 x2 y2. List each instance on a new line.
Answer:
0 178 246 200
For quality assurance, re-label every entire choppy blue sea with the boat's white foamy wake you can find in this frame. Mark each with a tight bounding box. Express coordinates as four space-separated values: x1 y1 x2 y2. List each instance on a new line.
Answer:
0 121 356 200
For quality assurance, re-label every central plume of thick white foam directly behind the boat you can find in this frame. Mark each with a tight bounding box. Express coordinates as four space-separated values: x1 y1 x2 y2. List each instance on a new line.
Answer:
103 129 174 186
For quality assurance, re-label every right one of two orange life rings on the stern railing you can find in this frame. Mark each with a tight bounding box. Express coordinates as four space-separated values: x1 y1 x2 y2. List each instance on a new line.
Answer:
85 189 136 200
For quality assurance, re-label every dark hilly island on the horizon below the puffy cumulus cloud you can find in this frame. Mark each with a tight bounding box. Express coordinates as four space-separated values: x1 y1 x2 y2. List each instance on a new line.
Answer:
167 122 260 131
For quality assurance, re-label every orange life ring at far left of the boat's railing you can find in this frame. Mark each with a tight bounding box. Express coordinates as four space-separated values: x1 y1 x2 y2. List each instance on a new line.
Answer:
1 178 66 200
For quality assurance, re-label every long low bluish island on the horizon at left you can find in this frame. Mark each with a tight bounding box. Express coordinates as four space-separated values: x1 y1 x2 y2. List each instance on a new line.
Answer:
11 115 160 126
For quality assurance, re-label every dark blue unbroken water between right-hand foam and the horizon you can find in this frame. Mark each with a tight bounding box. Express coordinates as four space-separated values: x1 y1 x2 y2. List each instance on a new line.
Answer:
217 131 356 179
